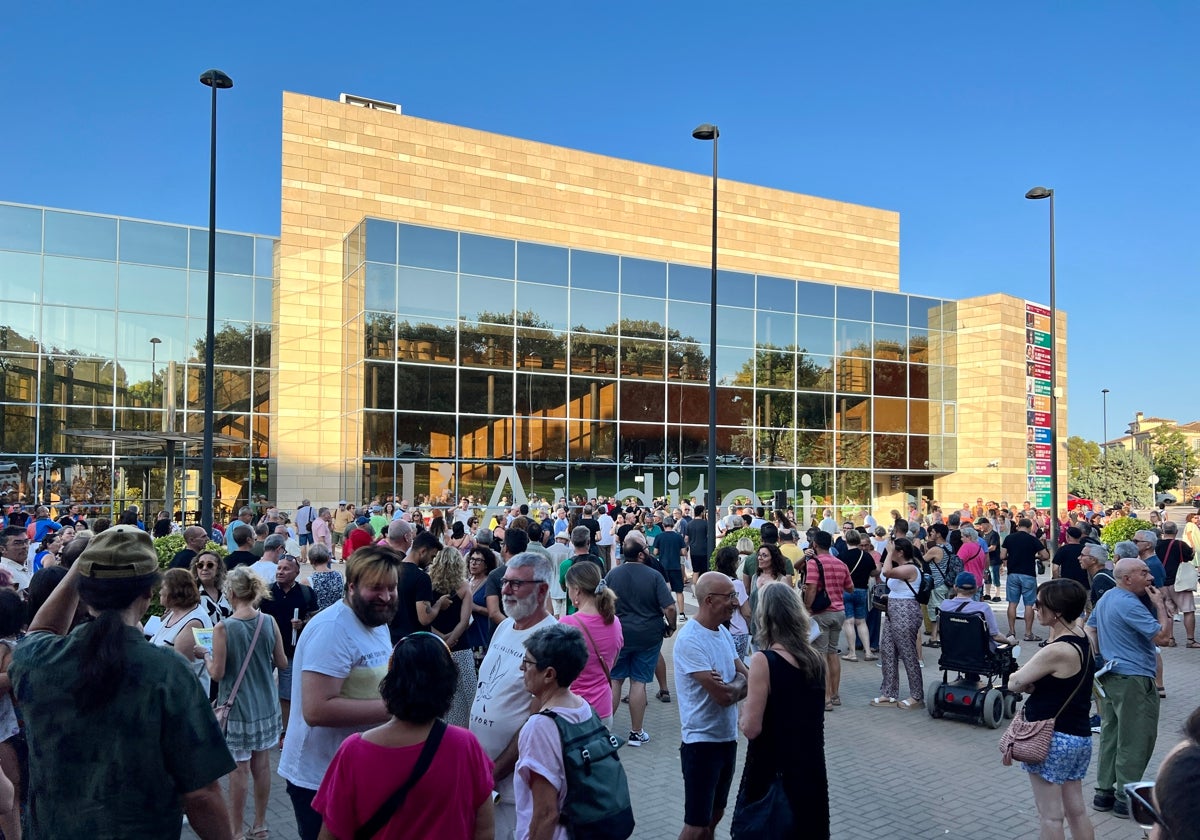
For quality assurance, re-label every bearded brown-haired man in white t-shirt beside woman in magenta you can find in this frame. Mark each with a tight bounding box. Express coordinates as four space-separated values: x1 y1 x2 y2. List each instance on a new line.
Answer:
280 546 400 840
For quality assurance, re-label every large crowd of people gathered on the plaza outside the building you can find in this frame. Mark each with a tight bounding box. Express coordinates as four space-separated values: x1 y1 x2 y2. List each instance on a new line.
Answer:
0 498 1200 840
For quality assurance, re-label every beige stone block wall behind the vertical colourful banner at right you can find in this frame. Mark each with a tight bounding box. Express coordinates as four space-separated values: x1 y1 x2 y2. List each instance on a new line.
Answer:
934 294 1067 518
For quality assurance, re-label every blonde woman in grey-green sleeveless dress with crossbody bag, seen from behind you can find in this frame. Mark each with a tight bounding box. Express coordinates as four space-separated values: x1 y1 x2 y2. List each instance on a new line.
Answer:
204 566 288 840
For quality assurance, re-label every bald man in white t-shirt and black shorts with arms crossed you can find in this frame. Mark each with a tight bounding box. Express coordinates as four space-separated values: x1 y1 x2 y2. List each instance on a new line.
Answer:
674 571 749 840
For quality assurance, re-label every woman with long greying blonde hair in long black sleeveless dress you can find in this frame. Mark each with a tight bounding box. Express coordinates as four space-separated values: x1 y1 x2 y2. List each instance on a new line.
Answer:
733 583 829 840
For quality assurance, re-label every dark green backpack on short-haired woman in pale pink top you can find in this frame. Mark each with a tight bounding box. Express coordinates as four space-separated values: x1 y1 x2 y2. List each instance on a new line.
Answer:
540 709 634 840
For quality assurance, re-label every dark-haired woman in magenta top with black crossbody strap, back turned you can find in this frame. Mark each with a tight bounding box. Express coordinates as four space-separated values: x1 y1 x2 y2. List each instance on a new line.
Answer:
312 630 494 840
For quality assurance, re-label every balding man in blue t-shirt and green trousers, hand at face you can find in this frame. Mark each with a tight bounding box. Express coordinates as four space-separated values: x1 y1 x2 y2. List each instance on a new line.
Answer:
1087 557 1171 818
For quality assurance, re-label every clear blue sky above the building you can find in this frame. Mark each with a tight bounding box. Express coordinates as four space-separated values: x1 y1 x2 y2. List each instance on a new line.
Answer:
0 0 1200 439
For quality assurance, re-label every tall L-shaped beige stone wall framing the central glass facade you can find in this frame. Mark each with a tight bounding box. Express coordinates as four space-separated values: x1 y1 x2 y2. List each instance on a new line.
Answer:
271 92 900 505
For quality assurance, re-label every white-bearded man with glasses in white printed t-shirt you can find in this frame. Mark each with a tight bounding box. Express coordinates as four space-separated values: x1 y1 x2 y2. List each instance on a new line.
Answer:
470 552 554 840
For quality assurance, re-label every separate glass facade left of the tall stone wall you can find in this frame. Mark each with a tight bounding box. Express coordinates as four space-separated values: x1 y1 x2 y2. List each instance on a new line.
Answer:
0 204 275 511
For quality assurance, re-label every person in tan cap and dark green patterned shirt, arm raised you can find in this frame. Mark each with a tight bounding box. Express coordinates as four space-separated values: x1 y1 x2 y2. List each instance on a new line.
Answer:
8 526 235 840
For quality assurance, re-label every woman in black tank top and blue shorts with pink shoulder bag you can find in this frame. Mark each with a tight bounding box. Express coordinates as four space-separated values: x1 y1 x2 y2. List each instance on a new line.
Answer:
1008 577 1096 840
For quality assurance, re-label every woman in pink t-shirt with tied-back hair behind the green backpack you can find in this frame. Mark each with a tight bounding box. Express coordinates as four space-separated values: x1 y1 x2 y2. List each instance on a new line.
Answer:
562 563 625 726
